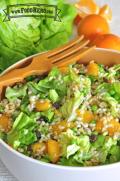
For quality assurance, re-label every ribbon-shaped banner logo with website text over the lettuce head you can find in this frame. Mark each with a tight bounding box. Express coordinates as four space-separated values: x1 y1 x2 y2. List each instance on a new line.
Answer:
3 4 61 22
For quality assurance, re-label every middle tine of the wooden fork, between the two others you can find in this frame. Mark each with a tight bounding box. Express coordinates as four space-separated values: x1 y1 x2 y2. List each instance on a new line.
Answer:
50 39 90 63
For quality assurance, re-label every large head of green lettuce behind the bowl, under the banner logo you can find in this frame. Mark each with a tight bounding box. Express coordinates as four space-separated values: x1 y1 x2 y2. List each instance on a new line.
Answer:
0 0 77 70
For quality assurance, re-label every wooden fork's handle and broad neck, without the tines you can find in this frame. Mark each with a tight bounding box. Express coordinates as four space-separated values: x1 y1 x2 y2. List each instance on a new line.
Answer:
0 55 52 87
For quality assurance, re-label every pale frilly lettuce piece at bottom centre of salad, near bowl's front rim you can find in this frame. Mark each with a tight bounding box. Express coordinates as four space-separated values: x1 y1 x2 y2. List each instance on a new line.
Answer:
60 130 90 163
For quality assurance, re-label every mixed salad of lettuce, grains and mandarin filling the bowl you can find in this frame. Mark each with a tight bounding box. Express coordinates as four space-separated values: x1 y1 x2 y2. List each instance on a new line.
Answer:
0 61 120 167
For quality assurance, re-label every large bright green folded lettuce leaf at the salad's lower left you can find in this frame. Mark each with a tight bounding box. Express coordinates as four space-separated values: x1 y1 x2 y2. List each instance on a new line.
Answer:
7 112 37 149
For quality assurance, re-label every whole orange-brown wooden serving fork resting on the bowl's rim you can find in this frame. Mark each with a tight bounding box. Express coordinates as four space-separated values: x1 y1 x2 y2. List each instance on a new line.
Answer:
0 36 94 99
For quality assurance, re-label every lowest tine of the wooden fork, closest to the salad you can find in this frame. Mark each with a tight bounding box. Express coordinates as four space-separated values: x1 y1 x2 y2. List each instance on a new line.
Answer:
54 46 95 67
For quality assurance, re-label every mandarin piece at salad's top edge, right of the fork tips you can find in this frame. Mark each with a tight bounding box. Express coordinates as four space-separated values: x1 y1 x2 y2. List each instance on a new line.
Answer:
87 62 99 76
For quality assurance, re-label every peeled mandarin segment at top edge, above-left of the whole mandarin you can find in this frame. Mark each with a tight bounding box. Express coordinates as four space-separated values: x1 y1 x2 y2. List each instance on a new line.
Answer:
75 0 99 17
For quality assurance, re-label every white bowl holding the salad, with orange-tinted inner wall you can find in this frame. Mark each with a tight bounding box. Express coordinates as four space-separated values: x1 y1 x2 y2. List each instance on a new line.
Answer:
0 49 120 181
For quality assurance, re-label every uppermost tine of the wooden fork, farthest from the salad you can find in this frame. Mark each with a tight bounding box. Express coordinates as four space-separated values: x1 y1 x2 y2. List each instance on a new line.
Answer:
47 35 84 58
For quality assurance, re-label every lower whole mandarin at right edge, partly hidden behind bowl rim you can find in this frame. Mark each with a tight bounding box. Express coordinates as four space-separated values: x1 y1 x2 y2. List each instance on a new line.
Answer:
92 34 120 51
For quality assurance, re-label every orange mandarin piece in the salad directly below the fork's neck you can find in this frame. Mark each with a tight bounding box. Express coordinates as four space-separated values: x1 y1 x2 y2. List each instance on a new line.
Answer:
35 100 51 111
